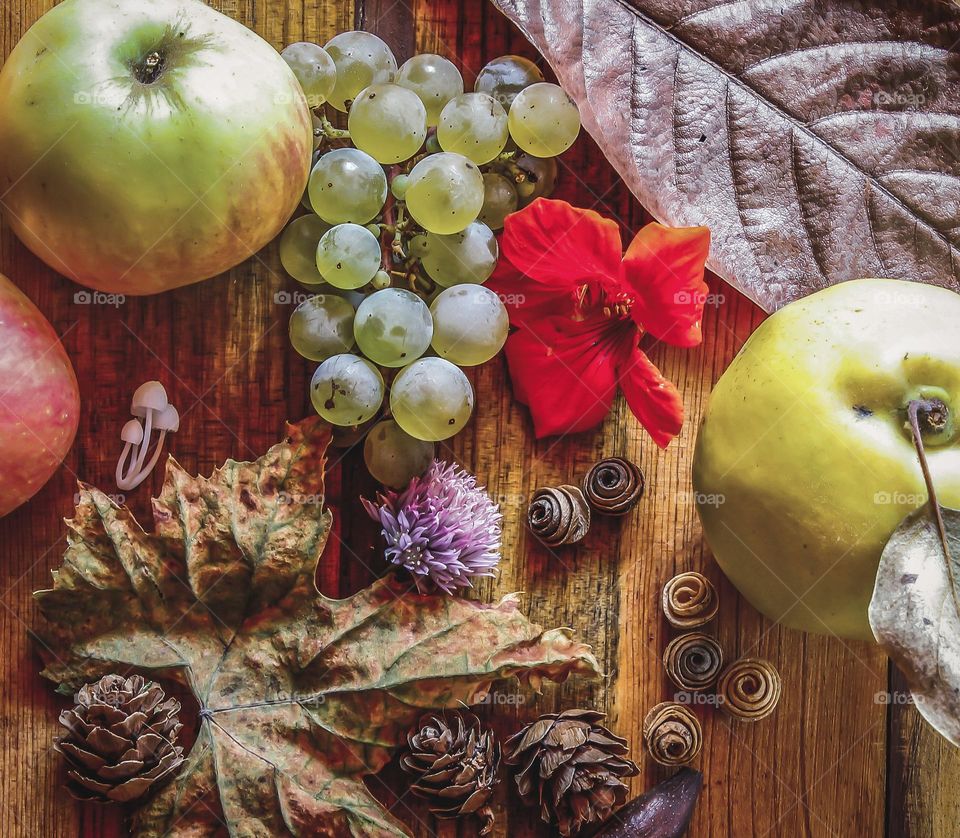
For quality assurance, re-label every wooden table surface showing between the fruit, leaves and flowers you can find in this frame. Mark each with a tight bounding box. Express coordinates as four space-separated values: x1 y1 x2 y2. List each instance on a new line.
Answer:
0 0 960 838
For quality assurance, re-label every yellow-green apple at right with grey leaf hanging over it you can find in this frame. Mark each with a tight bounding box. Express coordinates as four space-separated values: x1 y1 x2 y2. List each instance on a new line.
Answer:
693 279 960 639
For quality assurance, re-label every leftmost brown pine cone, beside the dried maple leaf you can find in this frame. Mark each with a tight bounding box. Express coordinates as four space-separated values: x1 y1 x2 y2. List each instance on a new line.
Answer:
54 675 183 803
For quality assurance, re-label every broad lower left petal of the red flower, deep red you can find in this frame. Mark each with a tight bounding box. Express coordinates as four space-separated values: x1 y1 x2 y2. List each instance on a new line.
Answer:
498 317 629 438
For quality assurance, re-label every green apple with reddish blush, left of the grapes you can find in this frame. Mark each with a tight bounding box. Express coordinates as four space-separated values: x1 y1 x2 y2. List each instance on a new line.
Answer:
0 0 313 295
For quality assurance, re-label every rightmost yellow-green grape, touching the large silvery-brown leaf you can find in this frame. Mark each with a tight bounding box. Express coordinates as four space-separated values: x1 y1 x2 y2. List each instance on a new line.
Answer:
509 82 580 157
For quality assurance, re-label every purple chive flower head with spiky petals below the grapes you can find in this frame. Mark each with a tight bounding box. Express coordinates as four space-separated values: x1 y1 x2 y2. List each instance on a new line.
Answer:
361 460 503 594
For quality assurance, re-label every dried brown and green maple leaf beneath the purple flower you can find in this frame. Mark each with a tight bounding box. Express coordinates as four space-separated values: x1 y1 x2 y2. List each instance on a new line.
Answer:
37 420 599 836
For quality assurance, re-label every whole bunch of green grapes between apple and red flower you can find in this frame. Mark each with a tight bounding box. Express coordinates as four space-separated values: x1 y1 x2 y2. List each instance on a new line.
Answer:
280 37 580 488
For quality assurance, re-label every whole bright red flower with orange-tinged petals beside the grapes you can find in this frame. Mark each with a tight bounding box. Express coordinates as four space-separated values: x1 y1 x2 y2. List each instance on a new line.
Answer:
489 198 710 448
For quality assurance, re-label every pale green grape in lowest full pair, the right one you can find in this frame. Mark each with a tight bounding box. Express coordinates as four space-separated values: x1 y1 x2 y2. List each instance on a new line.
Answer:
390 358 473 442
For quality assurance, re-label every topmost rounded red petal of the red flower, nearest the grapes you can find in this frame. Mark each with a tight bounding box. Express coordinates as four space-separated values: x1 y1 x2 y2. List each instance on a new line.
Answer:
500 198 623 291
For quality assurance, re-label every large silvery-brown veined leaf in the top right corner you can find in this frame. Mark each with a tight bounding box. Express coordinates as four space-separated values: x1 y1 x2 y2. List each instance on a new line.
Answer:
494 0 960 311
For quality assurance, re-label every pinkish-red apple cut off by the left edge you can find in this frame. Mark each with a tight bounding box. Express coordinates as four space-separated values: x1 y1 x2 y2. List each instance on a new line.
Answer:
0 274 80 517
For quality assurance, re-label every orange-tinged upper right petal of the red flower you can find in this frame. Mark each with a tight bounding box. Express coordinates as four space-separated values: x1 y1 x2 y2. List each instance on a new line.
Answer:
623 223 710 346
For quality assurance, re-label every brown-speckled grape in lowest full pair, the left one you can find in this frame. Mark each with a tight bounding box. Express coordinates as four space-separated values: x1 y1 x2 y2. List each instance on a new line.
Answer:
310 354 384 426
